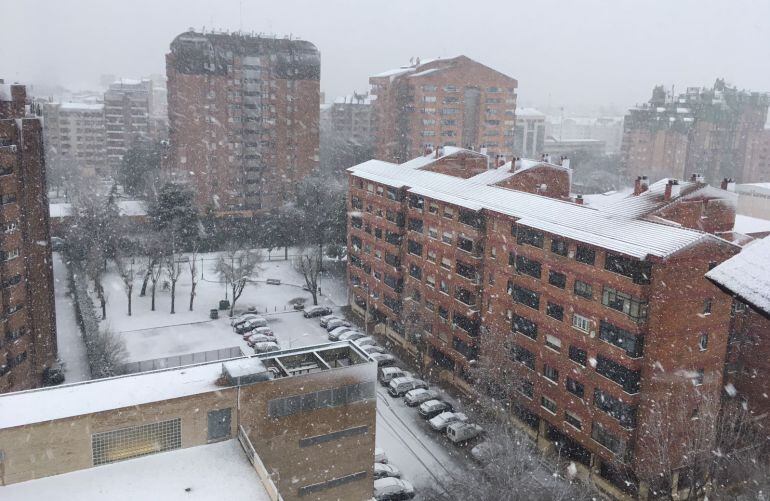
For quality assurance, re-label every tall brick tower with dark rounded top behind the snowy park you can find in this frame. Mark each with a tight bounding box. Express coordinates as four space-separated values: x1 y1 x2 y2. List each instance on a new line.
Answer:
166 31 321 211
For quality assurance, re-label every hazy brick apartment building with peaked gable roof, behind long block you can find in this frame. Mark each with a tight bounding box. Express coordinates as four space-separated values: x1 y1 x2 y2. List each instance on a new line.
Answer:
369 56 518 163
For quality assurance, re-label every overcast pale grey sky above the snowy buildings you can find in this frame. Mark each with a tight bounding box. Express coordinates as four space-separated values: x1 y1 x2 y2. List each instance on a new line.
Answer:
0 0 770 111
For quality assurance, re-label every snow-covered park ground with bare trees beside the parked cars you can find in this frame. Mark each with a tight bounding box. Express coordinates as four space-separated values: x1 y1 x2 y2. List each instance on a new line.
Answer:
94 252 346 362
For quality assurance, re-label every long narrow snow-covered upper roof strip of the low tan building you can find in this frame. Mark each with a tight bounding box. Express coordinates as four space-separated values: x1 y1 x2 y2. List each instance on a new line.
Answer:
0 362 222 428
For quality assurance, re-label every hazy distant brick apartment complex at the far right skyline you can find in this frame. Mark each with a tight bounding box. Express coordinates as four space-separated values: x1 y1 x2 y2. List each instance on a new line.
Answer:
622 80 770 183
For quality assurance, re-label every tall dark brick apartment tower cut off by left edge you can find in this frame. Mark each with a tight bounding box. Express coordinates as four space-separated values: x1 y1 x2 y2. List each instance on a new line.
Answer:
0 80 56 392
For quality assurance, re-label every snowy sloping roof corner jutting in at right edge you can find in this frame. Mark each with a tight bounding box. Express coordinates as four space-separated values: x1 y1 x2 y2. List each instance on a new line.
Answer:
706 237 770 313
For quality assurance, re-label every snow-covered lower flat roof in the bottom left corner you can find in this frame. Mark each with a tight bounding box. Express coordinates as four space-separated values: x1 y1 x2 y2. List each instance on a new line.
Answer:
0 440 270 501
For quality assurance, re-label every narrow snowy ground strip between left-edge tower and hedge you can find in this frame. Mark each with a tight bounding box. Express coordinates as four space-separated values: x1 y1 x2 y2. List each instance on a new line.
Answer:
53 252 91 383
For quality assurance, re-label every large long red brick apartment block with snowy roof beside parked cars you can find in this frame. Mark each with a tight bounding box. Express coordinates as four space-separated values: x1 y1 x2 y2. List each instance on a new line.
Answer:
348 148 739 497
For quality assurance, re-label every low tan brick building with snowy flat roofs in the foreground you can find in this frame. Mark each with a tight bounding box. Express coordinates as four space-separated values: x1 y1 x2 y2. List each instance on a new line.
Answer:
0 342 377 501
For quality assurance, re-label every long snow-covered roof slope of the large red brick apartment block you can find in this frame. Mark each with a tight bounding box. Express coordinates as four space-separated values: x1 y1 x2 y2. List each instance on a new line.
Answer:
348 160 728 259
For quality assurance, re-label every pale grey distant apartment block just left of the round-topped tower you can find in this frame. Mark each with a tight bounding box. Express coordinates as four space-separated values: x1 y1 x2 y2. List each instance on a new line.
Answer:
104 79 152 170
